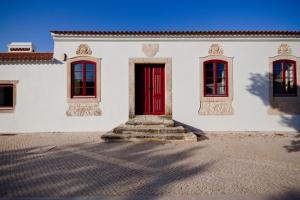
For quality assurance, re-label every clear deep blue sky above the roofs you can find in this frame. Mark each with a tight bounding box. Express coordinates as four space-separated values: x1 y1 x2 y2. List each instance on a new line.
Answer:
0 0 300 52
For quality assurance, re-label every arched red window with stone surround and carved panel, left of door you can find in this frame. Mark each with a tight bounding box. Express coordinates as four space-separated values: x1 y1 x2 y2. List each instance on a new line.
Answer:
66 56 102 116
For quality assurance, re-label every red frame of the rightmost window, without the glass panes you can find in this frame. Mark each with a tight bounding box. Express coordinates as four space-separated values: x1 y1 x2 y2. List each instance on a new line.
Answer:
272 60 297 97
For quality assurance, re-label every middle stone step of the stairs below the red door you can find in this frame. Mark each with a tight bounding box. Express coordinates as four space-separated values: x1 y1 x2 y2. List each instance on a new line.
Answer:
113 125 185 134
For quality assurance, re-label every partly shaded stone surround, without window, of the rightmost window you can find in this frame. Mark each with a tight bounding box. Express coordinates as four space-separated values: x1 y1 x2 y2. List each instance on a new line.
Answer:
268 44 300 115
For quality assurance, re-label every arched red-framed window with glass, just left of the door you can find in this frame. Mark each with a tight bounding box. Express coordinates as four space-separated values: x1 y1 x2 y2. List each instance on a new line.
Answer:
71 61 96 98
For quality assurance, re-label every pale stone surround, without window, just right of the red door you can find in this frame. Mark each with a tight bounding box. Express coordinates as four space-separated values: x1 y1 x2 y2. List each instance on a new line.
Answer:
199 44 234 115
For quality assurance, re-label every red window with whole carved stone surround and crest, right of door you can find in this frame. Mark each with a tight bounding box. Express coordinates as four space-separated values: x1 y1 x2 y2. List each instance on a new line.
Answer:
199 44 234 115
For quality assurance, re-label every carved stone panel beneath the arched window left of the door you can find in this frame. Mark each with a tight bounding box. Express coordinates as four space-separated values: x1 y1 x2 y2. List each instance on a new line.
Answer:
66 103 102 116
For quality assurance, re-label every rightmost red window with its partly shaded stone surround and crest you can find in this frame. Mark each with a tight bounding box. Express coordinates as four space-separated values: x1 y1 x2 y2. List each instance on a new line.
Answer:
268 44 300 115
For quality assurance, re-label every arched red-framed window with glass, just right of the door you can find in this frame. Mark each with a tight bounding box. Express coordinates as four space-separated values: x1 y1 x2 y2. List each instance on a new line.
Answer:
203 60 228 97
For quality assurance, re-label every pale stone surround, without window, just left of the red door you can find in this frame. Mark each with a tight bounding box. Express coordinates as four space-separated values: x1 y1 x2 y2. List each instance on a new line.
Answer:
66 56 102 116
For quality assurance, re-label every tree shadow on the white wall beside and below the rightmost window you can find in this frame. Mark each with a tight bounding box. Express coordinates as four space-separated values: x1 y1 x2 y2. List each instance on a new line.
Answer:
247 73 300 152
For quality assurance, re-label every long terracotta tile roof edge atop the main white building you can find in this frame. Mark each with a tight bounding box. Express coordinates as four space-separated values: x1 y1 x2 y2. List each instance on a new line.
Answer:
51 31 300 37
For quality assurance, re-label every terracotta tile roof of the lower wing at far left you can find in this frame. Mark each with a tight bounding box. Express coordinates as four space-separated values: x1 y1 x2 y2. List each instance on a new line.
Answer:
0 52 53 62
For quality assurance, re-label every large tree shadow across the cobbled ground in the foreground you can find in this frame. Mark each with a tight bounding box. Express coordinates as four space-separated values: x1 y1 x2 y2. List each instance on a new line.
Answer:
0 142 215 199
